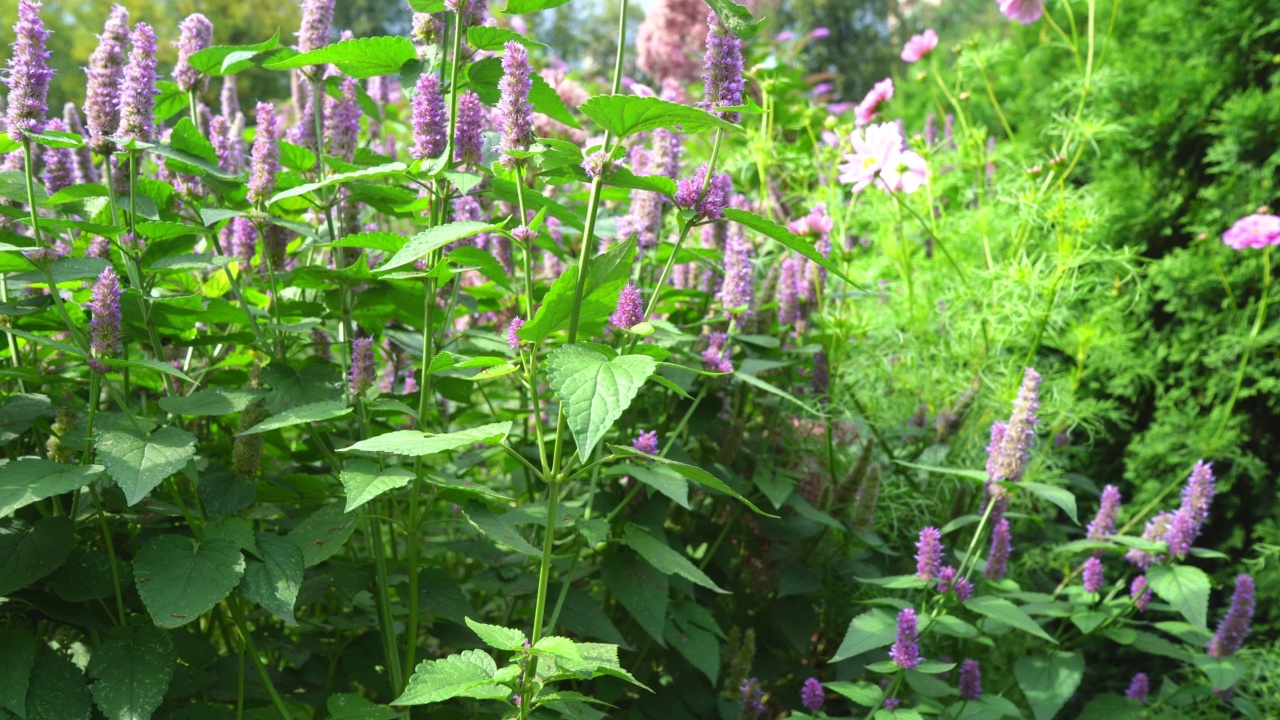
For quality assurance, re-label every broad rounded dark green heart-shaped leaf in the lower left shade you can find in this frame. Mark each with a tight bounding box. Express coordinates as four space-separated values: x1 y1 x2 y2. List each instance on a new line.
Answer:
133 536 244 628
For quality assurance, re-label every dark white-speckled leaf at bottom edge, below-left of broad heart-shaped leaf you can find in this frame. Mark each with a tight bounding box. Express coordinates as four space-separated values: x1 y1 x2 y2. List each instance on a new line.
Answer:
88 626 178 720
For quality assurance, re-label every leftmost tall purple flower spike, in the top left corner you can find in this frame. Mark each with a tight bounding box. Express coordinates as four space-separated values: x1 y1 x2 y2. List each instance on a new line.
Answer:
4 0 54 140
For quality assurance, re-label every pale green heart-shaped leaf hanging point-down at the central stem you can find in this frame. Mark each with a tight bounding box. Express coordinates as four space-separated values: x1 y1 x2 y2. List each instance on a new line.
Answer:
547 345 658 462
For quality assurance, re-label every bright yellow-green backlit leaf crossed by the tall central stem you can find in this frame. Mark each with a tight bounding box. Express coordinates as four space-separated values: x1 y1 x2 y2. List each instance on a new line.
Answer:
516 234 635 342
